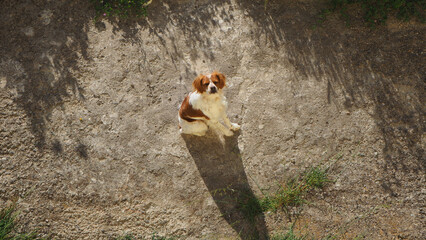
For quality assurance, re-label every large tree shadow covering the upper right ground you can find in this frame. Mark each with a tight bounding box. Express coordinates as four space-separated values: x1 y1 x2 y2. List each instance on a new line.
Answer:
237 0 426 191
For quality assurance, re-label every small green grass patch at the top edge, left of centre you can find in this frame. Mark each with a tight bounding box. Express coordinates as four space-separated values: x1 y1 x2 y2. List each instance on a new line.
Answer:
90 0 152 18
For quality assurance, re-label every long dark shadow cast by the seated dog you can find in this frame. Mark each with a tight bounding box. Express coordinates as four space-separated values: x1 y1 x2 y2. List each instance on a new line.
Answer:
182 132 268 240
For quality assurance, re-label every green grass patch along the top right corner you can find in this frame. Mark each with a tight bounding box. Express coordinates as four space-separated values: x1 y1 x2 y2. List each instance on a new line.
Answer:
320 0 426 26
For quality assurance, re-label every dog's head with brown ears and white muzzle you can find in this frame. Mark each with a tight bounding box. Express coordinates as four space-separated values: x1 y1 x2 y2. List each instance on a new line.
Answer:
192 71 226 94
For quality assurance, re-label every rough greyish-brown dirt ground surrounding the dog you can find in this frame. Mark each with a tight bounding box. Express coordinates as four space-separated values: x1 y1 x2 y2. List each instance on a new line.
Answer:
0 0 426 239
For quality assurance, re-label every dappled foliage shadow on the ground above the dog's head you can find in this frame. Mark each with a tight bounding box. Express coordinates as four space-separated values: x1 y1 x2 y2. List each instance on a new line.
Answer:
100 0 238 80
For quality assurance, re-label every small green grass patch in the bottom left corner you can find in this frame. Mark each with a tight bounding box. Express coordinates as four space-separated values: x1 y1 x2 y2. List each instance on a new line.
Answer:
0 205 41 240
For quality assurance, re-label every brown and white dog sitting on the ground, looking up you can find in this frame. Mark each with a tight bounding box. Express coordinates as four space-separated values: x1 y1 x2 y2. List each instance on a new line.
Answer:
178 71 240 136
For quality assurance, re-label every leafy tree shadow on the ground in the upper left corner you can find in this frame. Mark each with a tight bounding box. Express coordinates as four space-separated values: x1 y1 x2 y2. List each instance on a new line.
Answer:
0 0 90 154
